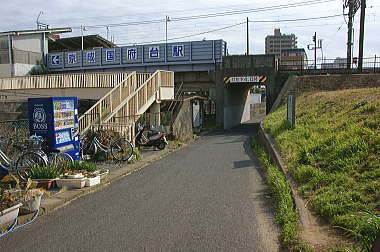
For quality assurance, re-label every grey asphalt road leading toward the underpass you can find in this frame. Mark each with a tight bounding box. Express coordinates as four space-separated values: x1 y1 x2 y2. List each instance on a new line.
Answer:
0 121 279 251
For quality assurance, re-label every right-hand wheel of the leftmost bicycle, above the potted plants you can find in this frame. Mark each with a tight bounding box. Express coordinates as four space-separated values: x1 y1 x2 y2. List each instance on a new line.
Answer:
16 152 47 181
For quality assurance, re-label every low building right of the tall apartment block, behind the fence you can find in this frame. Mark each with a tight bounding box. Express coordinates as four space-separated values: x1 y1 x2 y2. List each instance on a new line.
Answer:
279 48 308 70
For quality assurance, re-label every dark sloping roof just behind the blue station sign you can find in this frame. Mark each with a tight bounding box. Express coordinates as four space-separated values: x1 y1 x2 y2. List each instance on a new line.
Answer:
49 35 116 52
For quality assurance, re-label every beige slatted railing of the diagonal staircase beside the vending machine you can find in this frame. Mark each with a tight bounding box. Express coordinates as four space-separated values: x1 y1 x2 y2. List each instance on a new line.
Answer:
79 70 174 137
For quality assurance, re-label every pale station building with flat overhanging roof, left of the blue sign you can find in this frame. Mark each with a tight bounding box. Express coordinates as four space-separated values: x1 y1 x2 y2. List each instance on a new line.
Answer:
0 28 71 77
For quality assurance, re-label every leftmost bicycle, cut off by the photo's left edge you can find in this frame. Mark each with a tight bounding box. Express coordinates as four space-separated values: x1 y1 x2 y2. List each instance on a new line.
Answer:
0 137 48 181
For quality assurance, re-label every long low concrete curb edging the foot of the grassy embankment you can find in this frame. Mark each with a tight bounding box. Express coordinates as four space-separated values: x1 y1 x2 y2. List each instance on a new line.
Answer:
258 122 312 228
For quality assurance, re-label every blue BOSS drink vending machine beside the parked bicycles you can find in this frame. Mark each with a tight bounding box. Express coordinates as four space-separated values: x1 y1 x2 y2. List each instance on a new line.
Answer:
28 97 80 160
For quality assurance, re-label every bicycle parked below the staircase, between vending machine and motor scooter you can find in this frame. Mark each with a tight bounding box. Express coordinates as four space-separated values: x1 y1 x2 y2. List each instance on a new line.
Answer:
80 132 133 161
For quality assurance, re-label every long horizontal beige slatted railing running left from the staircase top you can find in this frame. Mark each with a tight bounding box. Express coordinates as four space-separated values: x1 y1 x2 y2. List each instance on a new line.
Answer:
0 72 131 90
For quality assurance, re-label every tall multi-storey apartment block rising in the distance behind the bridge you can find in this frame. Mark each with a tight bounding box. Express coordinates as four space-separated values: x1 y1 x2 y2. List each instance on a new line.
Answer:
265 29 297 60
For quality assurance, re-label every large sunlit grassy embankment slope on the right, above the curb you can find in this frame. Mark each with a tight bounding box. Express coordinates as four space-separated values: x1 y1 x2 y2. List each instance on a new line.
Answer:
263 88 380 250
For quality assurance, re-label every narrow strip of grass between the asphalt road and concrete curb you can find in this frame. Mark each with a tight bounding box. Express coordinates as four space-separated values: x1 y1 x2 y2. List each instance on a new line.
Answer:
251 138 304 251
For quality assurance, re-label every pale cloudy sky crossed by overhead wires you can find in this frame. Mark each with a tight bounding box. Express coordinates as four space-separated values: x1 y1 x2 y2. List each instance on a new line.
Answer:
0 0 380 59
